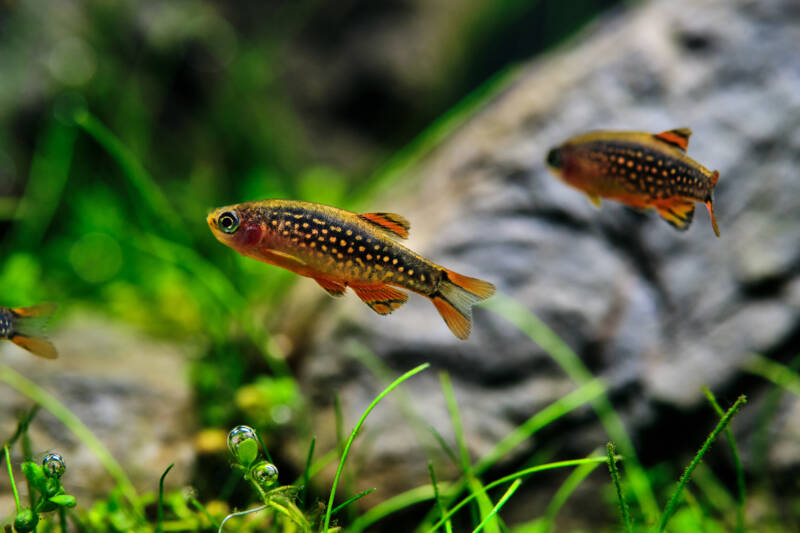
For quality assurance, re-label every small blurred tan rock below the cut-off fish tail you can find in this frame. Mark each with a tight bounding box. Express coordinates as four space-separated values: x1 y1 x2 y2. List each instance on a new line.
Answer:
0 317 194 509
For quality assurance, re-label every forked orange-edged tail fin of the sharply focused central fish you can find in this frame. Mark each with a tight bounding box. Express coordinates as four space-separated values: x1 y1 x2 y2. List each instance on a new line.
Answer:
431 269 494 340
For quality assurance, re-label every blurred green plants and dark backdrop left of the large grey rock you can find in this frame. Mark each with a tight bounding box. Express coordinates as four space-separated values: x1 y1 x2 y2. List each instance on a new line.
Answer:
0 0 615 427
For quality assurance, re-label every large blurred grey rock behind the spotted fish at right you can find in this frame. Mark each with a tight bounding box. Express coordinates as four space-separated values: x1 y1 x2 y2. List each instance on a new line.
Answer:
288 0 800 504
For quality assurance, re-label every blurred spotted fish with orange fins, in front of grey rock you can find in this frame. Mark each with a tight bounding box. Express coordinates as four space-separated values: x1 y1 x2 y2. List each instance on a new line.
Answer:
547 128 719 237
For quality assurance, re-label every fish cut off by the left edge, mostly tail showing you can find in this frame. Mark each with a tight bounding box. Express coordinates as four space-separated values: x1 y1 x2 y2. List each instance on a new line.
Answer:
0 303 58 359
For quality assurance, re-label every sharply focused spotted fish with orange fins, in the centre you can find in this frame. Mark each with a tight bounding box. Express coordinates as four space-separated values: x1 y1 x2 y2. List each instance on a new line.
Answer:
208 200 494 339
